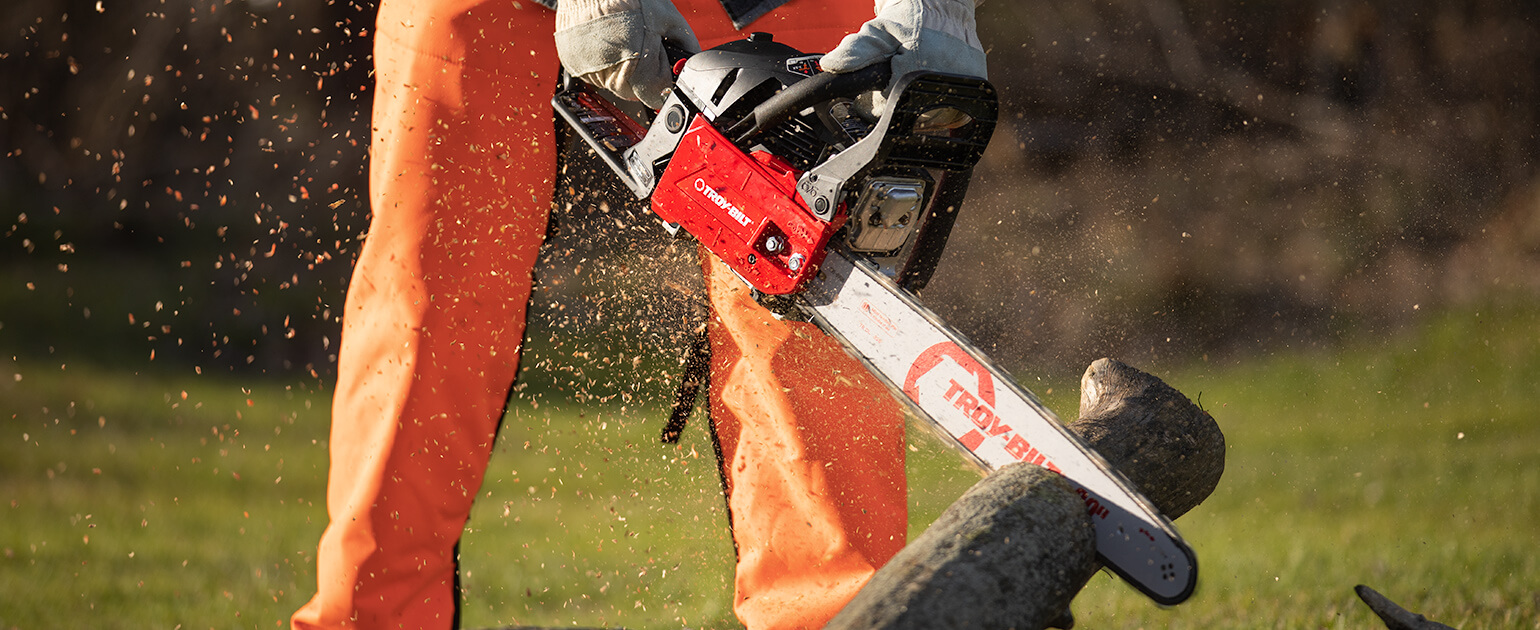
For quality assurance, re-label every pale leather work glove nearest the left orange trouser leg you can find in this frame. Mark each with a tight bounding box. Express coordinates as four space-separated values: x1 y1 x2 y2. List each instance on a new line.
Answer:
556 0 701 109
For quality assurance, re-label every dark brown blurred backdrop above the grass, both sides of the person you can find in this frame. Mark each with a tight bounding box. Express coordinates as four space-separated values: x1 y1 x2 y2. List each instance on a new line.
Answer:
0 0 1540 377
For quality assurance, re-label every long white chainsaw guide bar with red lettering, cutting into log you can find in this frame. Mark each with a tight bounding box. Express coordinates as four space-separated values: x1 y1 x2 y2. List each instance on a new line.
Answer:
799 247 1198 605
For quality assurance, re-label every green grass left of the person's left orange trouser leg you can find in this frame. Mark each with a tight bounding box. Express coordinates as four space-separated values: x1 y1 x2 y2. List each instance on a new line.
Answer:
0 362 325 628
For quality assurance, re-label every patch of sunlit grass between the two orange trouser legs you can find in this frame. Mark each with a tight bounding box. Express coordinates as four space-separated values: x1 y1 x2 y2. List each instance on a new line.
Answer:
460 405 733 627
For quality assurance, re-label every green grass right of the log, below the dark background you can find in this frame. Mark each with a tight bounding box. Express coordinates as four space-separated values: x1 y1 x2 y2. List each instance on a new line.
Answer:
1076 301 1540 628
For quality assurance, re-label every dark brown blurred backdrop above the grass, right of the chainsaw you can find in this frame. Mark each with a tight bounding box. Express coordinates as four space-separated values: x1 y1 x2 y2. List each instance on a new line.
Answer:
954 0 1540 371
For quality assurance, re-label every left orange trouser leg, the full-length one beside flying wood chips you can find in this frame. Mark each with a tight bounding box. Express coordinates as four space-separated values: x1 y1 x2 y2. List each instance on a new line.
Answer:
293 0 556 628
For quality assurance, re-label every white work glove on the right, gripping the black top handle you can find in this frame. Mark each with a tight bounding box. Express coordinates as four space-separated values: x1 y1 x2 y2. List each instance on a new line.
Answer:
819 0 987 86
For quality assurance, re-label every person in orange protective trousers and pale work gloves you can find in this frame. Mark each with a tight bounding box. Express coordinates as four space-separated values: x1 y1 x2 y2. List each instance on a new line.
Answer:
291 0 984 630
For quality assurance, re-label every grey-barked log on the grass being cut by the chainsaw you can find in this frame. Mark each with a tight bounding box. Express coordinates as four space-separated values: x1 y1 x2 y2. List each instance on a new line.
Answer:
825 359 1224 630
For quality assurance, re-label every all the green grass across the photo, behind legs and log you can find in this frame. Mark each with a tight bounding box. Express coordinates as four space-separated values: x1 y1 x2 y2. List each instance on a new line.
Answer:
0 307 1540 628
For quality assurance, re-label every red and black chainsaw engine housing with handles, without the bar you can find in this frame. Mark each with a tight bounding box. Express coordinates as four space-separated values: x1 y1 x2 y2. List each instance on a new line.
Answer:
553 34 998 296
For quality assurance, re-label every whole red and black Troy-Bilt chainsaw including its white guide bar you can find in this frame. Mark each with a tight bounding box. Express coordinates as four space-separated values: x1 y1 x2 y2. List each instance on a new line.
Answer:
553 32 1198 605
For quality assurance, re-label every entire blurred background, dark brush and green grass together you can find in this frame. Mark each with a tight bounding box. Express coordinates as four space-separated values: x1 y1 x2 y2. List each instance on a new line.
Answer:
0 0 1540 627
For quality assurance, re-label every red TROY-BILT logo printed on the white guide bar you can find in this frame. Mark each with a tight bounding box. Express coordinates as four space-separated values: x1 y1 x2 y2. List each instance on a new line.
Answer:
904 342 1060 473
